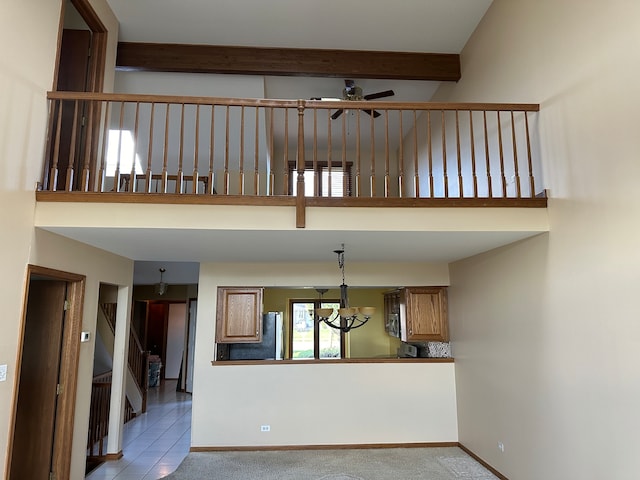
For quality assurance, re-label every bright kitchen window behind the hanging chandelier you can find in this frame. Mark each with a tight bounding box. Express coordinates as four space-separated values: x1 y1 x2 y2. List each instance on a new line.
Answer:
289 300 344 359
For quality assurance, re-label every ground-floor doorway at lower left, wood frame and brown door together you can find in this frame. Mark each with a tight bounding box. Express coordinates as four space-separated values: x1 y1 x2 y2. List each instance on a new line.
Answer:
7 265 85 480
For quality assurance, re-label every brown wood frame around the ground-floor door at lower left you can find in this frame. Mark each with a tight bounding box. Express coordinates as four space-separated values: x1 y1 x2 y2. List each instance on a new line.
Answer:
5 264 86 480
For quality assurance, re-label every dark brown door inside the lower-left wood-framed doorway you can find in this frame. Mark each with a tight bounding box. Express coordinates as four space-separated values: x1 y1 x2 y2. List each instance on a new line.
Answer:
9 280 67 480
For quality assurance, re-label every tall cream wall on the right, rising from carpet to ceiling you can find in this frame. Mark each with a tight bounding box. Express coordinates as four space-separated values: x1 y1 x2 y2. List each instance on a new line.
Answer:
437 0 640 480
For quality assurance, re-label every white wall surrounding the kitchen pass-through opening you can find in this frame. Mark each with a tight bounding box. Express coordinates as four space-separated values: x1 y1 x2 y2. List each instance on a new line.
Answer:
192 262 457 447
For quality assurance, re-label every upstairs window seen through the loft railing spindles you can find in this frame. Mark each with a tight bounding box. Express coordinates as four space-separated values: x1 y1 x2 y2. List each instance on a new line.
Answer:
289 162 351 198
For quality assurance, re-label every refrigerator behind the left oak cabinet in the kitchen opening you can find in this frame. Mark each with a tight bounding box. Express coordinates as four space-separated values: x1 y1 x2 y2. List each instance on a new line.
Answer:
228 312 284 360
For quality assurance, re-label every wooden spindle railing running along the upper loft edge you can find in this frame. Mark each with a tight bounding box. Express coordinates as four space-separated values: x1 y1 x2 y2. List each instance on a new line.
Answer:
41 92 543 204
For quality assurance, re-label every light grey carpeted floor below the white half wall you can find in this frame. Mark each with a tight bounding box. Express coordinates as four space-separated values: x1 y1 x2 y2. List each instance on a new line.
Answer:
164 447 497 480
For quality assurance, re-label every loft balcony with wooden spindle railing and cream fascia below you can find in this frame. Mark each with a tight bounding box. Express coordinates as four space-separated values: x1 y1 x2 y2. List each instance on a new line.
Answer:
36 92 548 260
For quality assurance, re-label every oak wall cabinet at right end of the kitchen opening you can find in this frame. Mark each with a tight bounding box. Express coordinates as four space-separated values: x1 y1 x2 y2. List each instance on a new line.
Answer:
400 287 449 342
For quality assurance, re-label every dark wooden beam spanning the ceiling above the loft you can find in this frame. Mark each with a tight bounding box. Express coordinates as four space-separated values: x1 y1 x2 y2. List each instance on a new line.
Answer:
116 42 460 82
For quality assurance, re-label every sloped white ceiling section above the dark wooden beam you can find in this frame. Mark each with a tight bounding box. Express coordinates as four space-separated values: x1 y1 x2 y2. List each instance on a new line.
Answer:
107 0 491 53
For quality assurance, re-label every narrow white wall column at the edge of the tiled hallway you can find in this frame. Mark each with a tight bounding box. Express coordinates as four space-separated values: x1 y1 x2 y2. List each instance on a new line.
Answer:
107 287 131 456
